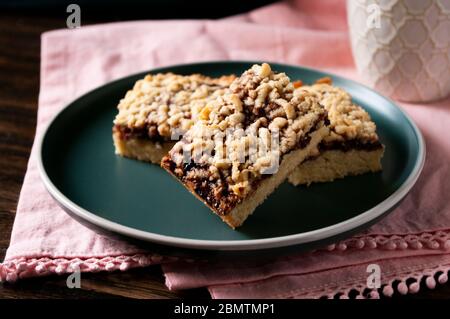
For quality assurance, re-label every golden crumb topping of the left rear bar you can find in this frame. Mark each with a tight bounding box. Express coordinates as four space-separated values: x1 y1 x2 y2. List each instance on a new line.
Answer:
114 73 235 140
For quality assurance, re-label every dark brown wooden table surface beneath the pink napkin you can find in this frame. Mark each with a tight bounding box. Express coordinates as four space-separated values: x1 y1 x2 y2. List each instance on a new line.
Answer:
0 9 450 298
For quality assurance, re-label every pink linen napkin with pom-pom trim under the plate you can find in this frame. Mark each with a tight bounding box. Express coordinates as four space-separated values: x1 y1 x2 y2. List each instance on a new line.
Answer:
0 0 450 298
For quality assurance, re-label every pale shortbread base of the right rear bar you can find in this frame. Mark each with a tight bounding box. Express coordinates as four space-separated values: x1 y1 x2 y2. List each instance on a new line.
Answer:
288 147 384 186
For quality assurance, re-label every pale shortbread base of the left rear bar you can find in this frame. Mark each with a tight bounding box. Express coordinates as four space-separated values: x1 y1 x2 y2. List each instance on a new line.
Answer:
113 131 175 165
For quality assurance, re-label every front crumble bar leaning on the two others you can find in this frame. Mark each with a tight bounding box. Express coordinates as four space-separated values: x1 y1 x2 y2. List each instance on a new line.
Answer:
161 63 328 228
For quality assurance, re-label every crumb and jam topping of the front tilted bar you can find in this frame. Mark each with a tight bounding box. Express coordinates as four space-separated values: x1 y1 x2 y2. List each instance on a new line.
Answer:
161 63 326 209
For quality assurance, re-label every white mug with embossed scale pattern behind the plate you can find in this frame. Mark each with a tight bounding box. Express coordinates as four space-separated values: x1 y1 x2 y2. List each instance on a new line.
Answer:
347 0 450 102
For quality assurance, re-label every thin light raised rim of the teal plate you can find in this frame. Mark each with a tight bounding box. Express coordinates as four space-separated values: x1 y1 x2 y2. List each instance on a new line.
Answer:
36 60 426 251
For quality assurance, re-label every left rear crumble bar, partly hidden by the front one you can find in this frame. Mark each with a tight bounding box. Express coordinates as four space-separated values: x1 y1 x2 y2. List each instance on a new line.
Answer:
113 73 235 164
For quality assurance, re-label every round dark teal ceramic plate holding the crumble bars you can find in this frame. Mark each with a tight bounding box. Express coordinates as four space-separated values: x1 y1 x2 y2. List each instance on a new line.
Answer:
39 62 425 251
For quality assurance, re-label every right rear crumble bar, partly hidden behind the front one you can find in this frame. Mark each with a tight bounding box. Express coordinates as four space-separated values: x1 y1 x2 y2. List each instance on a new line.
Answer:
289 79 384 185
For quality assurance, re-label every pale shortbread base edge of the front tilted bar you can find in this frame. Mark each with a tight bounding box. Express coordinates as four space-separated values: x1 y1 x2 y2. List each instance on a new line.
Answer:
223 127 329 228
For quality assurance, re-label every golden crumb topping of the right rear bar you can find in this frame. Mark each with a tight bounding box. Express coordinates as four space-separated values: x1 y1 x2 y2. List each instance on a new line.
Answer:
296 84 379 144
